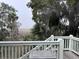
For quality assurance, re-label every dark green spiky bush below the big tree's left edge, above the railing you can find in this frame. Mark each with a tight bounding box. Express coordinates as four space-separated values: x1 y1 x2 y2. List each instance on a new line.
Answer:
32 24 45 40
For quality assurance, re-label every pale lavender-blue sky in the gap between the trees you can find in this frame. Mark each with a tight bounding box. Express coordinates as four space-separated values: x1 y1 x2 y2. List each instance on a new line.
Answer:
0 0 35 29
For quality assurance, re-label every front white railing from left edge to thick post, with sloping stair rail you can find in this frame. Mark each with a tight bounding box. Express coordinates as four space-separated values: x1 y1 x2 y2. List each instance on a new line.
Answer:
0 36 63 59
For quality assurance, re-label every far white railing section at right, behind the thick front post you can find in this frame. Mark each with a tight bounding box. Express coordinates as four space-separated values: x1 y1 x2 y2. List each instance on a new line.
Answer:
54 35 79 55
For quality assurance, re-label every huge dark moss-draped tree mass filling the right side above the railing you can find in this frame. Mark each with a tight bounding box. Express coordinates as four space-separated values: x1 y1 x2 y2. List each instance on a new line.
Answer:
28 0 79 38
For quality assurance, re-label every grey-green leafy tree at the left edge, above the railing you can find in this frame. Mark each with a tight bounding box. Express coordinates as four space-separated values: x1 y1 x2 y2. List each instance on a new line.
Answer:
0 3 18 40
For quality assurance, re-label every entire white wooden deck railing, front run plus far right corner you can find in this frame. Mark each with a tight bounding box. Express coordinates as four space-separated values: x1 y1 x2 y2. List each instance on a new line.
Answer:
0 35 79 59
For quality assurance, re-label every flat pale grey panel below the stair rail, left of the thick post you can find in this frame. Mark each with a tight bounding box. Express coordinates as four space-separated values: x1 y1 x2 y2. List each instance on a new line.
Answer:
29 50 56 58
